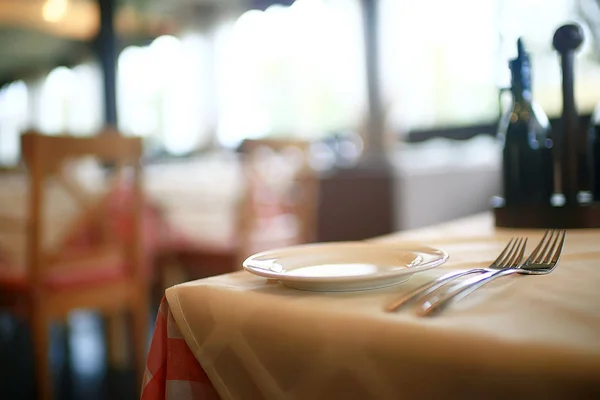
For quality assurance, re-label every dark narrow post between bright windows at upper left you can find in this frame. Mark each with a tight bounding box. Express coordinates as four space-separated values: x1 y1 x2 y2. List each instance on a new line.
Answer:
95 0 117 128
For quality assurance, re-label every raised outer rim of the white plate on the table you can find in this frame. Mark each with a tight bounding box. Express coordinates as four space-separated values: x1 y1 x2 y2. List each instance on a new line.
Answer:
242 241 450 284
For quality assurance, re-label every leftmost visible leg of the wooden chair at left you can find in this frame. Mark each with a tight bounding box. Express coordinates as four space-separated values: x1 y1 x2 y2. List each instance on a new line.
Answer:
30 305 53 400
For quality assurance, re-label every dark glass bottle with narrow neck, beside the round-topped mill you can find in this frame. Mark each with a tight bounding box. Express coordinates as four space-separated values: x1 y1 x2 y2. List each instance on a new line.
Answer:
498 39 554 206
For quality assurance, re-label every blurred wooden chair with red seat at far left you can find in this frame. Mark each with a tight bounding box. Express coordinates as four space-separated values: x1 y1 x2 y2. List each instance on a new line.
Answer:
0 132 149 399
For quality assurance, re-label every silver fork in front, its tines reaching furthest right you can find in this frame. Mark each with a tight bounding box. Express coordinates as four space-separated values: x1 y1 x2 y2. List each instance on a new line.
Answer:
417 229 567 317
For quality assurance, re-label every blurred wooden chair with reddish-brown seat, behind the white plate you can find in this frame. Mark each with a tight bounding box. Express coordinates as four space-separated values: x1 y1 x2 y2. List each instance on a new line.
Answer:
162 140 318 287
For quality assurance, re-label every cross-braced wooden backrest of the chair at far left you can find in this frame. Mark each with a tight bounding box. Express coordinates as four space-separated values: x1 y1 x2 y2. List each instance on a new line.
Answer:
21 132 143 283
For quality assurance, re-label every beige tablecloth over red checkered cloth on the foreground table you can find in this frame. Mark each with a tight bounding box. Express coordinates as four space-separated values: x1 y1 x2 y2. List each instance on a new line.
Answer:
167 214 600 399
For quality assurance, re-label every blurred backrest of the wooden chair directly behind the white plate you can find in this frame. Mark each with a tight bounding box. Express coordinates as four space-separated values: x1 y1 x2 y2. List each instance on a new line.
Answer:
238 139 318 260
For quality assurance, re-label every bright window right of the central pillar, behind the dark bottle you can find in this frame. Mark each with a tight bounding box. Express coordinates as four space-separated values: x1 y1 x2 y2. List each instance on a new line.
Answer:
380 0 600 131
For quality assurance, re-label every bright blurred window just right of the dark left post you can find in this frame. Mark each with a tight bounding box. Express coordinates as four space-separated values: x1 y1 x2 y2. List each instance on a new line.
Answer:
117 34 213 154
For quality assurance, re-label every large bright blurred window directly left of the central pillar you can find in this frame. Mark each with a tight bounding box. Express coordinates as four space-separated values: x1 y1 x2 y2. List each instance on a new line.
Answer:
216 0 365 146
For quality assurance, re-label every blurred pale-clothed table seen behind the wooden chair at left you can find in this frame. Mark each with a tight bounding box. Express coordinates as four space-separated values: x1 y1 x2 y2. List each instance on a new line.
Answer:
0 158 241 275
